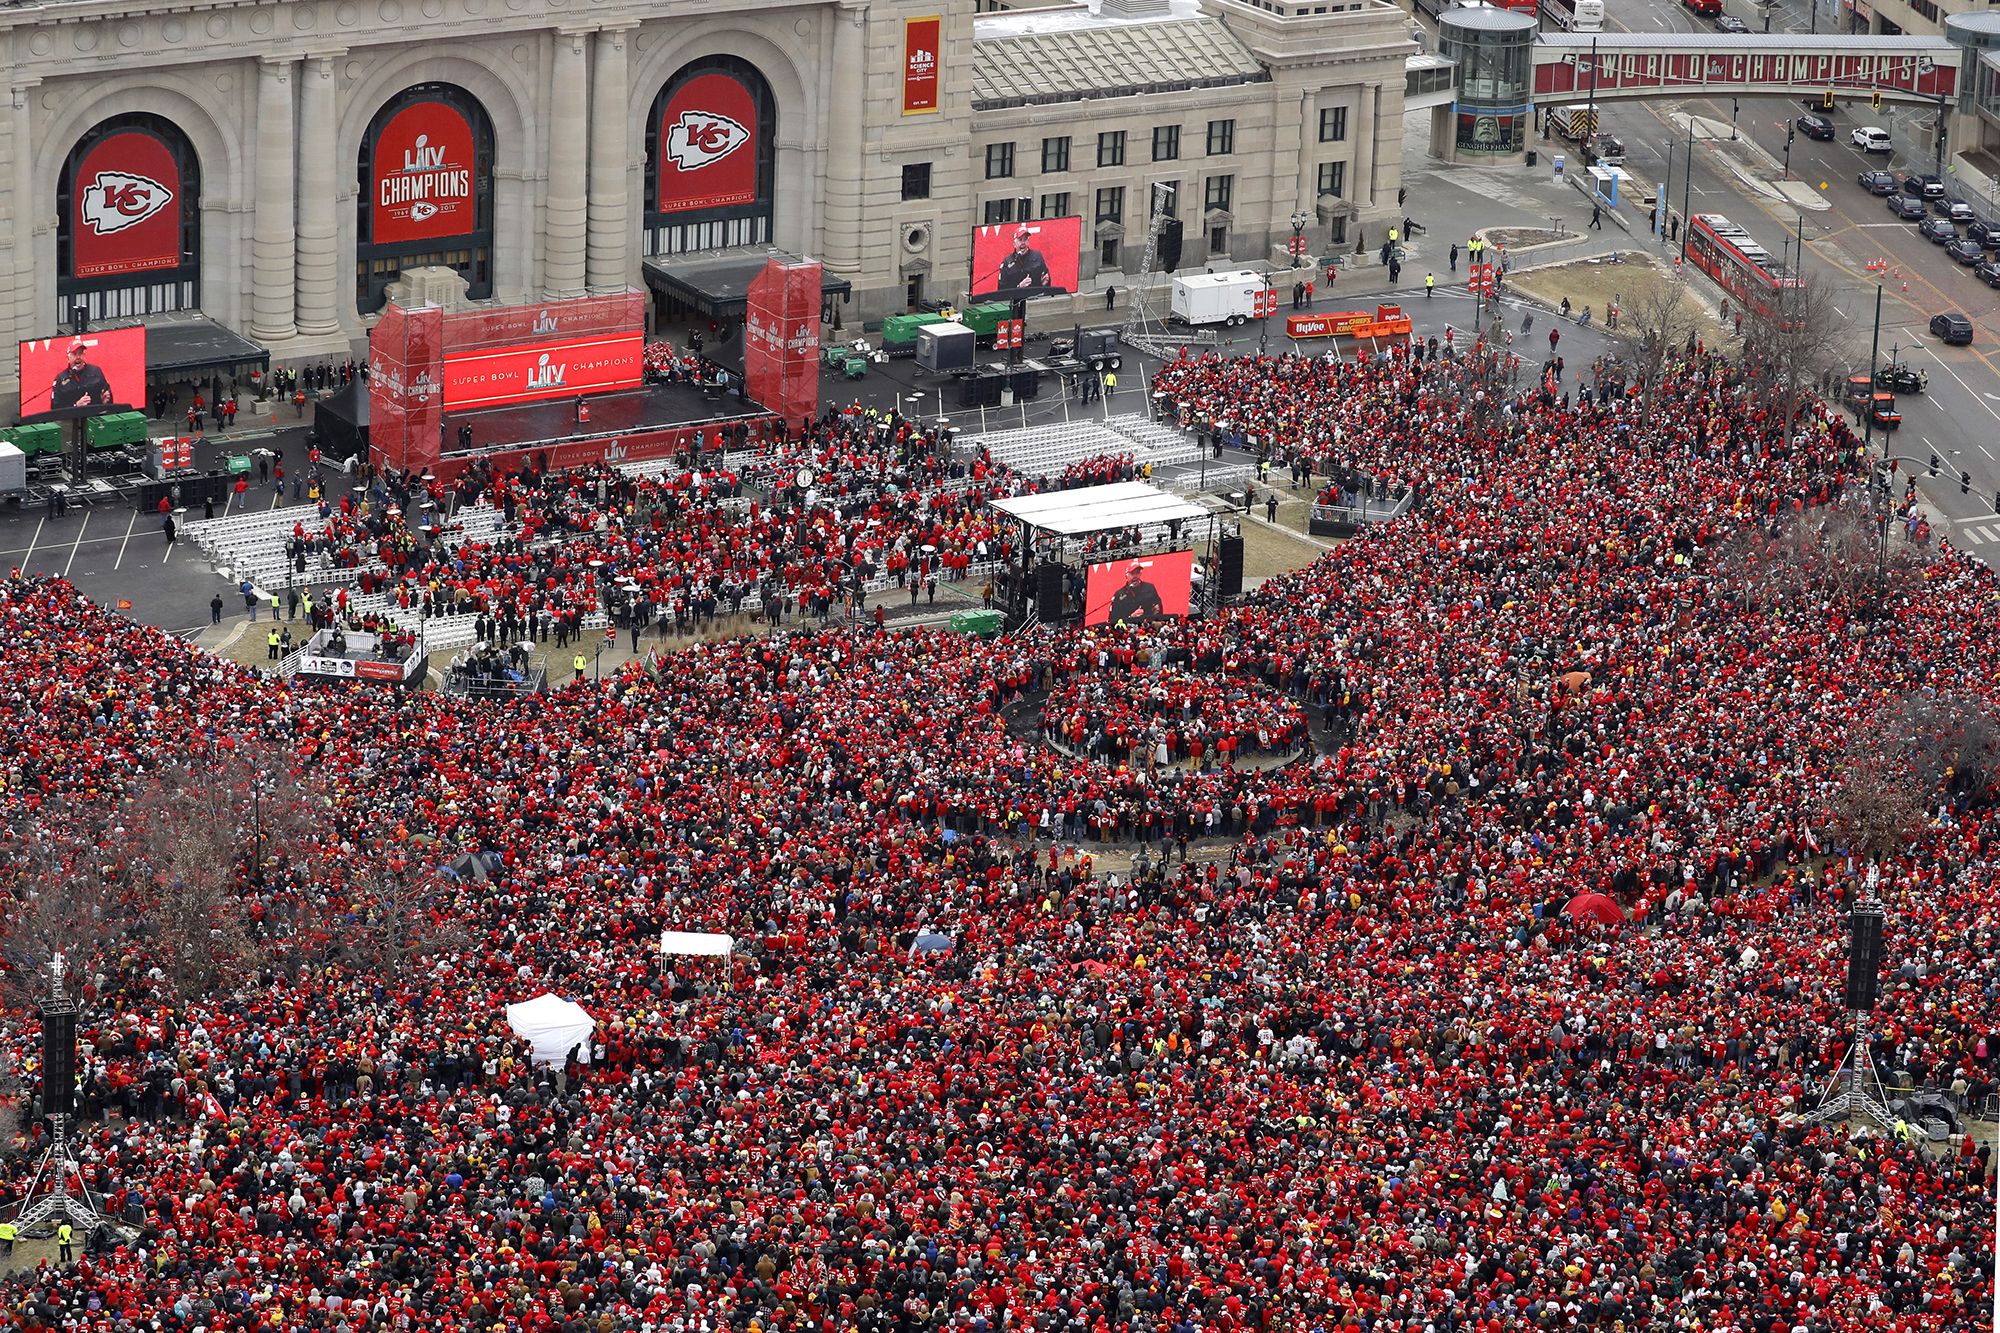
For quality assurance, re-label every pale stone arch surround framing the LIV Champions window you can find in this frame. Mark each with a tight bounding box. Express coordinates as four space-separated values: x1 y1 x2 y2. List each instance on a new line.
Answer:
334 42 544 322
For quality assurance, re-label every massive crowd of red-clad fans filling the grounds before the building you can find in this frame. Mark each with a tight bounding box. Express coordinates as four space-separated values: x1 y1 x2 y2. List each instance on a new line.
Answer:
0 324 2000 1333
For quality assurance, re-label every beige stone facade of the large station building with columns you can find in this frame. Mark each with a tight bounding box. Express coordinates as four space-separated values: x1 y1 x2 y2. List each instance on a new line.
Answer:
0 0 1410 412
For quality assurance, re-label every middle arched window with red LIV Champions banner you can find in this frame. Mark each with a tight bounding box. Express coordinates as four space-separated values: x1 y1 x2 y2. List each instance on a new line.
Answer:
354 84 494 314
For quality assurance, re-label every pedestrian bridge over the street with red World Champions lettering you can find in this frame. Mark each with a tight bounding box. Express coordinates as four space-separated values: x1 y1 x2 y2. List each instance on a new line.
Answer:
1528 32 1972 106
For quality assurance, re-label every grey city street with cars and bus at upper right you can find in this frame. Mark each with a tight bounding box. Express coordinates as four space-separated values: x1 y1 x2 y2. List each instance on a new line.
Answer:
1576 0 2000 562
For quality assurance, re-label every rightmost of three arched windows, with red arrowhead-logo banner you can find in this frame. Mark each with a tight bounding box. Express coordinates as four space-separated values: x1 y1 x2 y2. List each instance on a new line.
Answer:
646 56 778 254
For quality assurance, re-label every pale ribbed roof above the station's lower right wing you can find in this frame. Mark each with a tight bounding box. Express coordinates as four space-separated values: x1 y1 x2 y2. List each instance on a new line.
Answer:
972 4 1270 110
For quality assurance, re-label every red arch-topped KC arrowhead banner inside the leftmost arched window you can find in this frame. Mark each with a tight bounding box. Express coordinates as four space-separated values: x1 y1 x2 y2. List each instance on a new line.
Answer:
70 130 182 278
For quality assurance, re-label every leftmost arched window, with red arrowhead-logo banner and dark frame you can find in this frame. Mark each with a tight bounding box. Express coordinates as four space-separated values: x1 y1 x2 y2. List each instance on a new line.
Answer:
54 114 202 324
